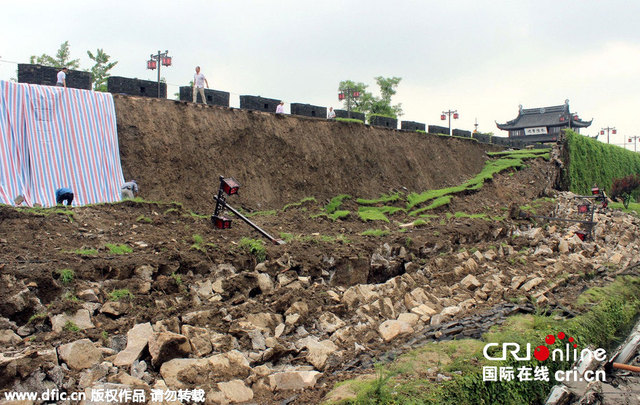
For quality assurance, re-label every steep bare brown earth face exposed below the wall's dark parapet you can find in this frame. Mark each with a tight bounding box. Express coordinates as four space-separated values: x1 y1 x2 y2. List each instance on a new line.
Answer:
114 95 494 209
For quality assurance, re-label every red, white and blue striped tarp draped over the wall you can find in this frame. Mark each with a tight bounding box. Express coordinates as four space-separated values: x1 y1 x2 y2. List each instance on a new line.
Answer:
0 81 124 207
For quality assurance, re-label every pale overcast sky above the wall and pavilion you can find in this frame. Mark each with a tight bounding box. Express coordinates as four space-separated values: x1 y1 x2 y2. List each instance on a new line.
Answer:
0 0 640 145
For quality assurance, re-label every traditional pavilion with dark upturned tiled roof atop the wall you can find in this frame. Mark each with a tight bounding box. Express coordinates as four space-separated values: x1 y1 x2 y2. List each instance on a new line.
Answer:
496 100 593 142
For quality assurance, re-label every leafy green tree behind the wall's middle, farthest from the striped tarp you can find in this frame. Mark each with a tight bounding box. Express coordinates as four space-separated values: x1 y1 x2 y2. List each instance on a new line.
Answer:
338 76 402 118
